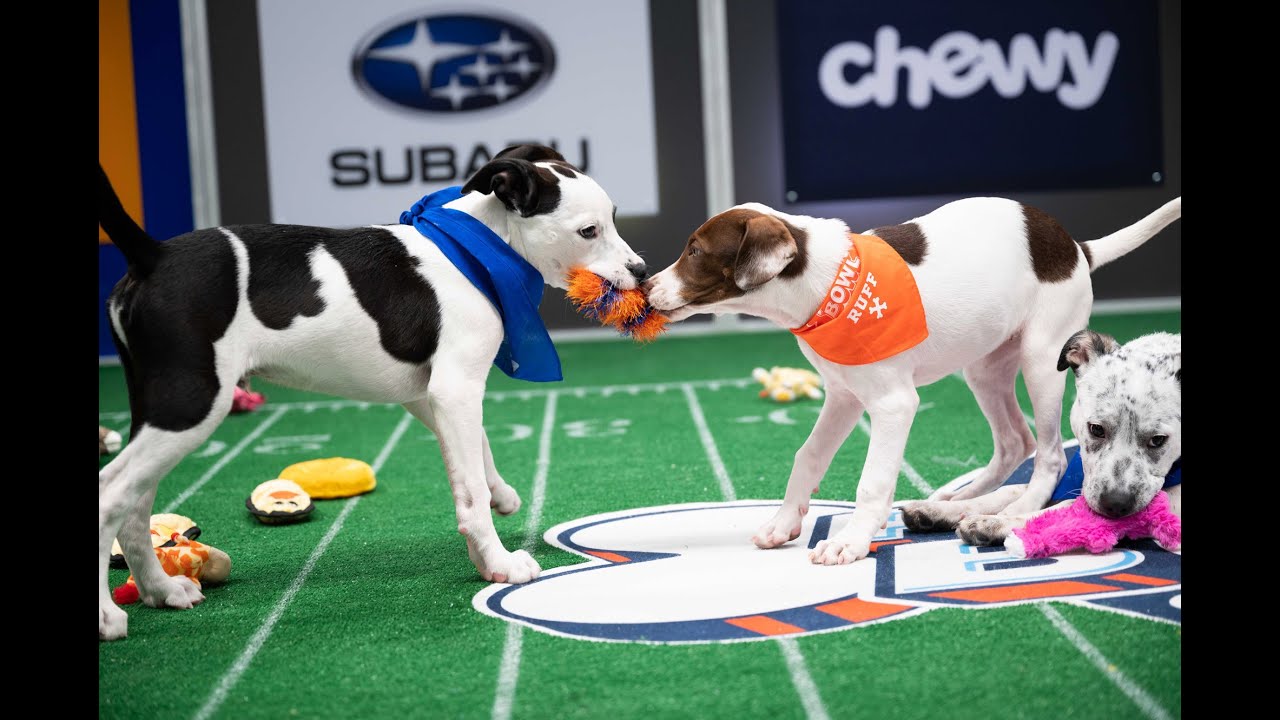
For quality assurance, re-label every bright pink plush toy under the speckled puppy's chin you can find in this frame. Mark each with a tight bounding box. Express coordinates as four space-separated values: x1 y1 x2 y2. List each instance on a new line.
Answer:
1005 491 1183 557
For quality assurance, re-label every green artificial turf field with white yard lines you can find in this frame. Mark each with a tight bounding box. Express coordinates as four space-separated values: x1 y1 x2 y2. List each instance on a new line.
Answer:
99 313 1181 720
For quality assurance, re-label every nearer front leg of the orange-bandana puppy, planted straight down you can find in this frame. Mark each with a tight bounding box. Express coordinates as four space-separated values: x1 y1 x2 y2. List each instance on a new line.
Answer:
809 375 920 565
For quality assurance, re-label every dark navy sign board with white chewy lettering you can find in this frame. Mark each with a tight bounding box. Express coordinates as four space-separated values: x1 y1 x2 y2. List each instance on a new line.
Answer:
777 0 1164 201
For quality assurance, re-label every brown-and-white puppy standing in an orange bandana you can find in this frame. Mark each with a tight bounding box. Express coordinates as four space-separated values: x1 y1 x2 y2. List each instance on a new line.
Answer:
645 197 1181 565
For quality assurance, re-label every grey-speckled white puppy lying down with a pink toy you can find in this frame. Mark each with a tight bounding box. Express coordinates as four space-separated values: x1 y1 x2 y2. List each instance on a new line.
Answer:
902 329 1183 544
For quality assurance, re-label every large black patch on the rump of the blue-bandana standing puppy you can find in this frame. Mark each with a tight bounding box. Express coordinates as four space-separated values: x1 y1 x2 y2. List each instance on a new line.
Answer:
108 229 239 434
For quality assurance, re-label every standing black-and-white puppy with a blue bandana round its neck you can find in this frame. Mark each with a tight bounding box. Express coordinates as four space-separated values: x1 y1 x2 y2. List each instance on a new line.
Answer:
97 145 645 639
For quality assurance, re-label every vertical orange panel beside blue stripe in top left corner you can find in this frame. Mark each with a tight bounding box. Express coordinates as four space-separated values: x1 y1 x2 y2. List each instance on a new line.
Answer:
97 0 142 245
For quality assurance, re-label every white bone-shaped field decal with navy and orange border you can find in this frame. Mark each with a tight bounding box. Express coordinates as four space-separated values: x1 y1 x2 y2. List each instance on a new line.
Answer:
472 500 1181 644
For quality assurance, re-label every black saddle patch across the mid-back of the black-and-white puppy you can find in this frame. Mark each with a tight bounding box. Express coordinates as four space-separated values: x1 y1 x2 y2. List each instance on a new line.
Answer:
227 225 440 363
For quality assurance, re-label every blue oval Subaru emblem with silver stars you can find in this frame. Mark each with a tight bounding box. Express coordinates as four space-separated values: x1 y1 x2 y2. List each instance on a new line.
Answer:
352 14 556 113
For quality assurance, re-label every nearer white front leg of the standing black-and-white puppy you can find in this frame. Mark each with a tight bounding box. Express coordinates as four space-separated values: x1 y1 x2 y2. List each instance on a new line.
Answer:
406 384 541 583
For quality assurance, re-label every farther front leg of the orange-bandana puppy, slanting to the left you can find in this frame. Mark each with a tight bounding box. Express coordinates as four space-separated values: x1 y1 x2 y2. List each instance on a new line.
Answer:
751 383 863 548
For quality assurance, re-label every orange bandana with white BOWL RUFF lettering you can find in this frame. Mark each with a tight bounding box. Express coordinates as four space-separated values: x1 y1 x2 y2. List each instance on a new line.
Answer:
791 233 929 365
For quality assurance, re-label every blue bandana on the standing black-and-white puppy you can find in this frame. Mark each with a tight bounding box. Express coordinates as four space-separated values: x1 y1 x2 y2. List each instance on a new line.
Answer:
401 186 563 382
